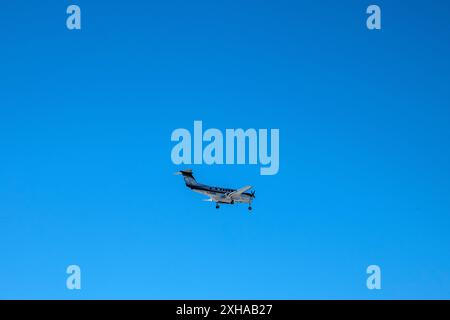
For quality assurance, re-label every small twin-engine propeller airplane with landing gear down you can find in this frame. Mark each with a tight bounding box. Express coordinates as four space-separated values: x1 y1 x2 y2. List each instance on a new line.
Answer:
175 169 255 210
